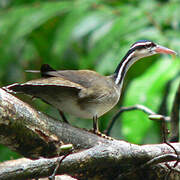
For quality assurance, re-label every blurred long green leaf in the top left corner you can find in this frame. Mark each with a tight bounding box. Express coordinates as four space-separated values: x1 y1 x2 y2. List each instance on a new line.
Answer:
0 1 72 67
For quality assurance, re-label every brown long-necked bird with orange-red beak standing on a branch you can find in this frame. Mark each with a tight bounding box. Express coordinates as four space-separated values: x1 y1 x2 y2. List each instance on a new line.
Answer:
3 40 176 134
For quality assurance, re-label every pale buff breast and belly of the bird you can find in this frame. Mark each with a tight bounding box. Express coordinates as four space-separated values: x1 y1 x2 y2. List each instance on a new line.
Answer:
46 87 119 119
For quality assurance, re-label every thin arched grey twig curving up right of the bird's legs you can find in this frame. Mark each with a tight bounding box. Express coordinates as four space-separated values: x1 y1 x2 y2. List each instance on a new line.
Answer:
104 104 169 135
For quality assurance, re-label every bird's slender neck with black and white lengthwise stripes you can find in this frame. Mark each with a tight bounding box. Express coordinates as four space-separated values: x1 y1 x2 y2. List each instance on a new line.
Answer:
114 50 139 89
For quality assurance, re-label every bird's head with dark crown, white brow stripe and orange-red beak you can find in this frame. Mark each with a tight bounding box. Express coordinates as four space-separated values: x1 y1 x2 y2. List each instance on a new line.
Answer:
129 40 176 59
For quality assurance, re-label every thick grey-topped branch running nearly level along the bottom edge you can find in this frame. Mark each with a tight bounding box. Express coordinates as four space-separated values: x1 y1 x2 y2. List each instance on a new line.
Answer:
0 143 180 180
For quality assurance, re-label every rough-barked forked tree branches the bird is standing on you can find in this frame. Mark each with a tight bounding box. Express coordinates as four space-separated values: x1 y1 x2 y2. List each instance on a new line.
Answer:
0 89 180 180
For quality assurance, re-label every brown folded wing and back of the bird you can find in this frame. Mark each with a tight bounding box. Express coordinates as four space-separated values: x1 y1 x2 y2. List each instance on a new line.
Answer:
9 65 109 99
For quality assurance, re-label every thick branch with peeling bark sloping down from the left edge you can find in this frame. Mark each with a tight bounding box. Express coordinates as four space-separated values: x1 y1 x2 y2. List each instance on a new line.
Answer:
0 89 105 158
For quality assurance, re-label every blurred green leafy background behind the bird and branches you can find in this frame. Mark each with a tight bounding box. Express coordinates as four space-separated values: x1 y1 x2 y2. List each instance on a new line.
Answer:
0 0 180 161
